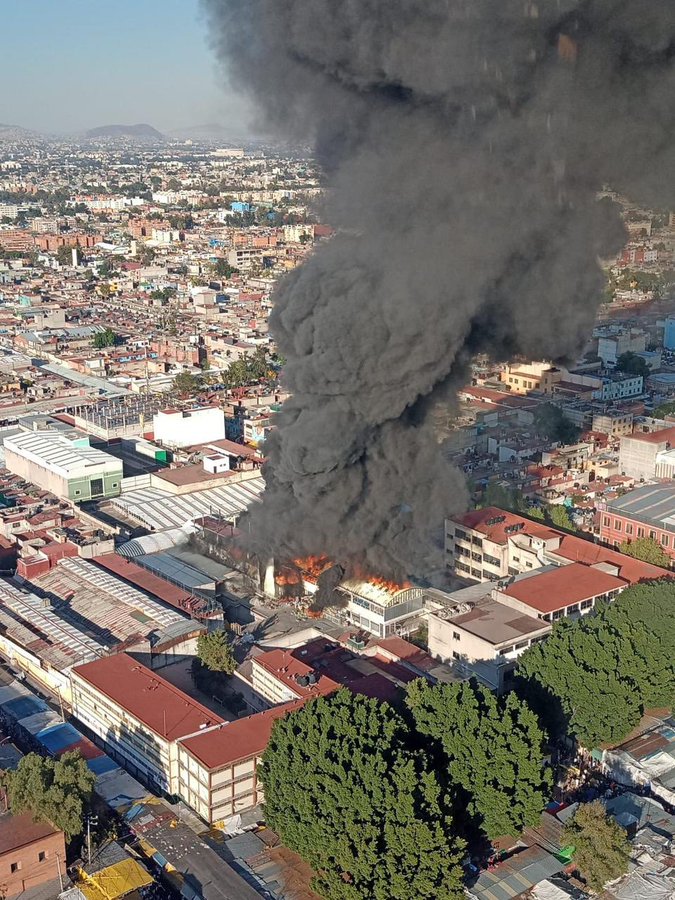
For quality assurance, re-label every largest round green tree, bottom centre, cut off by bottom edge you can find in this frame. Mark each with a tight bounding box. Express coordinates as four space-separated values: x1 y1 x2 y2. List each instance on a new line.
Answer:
261 688 464 900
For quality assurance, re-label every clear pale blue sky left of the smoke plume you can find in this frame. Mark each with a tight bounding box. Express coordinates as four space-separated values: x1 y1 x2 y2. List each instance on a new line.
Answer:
0 0 254 133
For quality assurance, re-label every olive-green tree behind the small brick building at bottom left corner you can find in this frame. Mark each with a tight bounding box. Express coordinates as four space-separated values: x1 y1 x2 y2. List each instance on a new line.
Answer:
1 751 96 840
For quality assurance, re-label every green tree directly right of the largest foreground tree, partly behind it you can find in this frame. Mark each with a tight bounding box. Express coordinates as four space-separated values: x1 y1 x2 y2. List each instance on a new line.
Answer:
406 678 553 839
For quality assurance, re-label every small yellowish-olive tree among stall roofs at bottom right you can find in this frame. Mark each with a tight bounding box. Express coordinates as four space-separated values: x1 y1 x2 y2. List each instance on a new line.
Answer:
563 800 630 893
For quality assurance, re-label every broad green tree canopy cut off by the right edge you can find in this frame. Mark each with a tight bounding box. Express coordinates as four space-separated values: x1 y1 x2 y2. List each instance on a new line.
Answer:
518 581 675 747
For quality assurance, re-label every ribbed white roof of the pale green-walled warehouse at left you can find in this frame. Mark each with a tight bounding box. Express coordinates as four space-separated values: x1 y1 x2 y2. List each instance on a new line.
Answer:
4 430 122 478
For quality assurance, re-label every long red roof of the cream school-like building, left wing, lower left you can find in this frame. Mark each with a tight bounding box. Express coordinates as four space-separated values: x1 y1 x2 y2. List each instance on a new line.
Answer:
73 653 225 741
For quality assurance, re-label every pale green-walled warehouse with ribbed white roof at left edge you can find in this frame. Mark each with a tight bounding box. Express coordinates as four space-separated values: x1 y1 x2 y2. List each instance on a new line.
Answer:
4 429 122 503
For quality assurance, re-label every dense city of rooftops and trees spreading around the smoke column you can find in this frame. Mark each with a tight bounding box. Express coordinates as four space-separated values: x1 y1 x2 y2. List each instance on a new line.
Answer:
0 136 675 900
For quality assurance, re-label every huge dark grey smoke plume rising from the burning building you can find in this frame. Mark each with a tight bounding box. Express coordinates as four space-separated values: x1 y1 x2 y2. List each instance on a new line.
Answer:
205 0 675 576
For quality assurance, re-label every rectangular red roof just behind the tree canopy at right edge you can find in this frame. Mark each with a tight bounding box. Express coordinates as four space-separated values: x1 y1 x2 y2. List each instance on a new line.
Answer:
502 563 626 613
